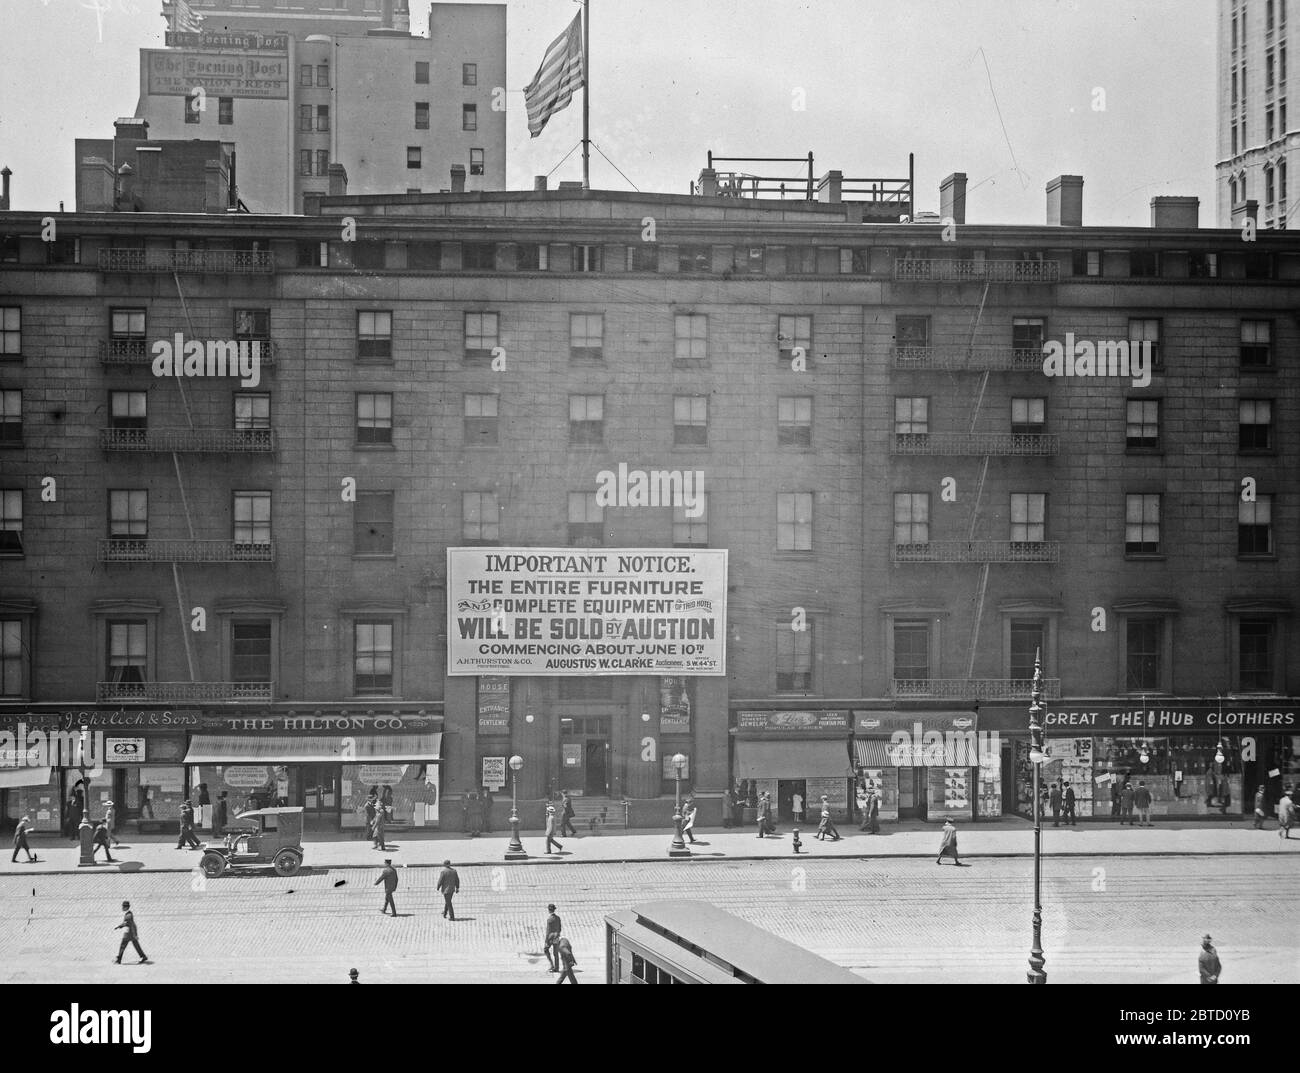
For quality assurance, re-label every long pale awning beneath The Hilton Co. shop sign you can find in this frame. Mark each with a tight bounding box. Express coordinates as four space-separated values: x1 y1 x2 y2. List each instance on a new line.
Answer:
185 732 442 763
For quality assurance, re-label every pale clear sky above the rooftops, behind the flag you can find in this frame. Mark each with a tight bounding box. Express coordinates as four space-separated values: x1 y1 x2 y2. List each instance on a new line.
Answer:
0 0 1216 226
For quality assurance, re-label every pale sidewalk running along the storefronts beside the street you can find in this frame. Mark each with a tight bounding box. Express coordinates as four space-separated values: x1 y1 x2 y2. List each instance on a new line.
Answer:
10 817 1300 877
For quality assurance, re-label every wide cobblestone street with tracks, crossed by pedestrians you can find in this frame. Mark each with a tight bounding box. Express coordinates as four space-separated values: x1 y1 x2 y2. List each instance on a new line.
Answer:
0 856 1300 983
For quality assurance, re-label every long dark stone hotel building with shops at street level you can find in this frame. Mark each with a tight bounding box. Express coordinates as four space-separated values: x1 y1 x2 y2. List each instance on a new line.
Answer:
0 159 1300 828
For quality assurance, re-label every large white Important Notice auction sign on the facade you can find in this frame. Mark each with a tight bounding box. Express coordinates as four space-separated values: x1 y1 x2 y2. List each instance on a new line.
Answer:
447 548 727 675
